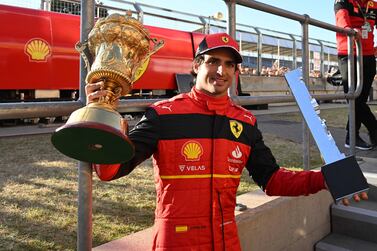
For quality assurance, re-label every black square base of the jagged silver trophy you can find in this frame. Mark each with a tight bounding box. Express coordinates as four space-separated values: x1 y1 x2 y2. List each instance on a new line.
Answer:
321 156 369 202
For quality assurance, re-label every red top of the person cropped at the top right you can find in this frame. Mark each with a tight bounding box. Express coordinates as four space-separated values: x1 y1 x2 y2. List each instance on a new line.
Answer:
334 0 377 56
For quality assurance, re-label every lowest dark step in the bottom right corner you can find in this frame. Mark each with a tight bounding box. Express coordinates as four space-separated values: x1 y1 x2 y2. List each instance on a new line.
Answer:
315 233 377 251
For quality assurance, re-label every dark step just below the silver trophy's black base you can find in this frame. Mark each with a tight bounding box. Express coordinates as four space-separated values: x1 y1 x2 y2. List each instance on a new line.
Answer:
331 195 377 244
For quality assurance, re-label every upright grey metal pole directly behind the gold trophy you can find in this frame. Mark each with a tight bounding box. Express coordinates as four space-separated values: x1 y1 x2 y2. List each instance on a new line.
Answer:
77 0 95 251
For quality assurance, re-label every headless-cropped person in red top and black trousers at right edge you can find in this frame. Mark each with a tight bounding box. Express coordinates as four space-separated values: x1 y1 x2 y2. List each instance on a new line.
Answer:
334 0 377 150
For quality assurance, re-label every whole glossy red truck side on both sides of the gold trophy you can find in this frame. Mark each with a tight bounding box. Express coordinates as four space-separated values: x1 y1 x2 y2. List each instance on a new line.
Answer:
0 5 203 90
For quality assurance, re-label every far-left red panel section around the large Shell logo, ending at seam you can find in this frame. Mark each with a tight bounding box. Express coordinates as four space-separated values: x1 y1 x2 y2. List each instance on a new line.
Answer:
0 5 51 89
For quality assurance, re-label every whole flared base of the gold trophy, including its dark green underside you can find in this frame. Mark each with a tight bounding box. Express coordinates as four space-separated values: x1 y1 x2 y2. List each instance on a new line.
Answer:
51 105 134 164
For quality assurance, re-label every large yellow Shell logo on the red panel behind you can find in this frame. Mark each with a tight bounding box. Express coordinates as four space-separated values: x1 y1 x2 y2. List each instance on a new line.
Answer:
25 38 51 62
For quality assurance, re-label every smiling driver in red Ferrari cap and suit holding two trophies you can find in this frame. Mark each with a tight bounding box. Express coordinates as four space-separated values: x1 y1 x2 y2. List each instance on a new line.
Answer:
86 33 366 251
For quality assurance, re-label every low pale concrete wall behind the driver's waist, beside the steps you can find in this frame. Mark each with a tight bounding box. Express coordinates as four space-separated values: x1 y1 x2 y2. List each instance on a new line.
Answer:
93 191 332 251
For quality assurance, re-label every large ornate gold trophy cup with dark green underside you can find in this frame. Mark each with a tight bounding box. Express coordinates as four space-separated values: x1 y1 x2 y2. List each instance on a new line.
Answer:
51 14 164 164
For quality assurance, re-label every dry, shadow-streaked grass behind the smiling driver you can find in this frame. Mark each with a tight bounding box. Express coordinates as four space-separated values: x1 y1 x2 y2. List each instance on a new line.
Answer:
0 113 322 250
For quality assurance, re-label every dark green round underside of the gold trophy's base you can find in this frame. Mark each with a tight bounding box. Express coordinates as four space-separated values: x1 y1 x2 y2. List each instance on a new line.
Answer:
51 122 134 164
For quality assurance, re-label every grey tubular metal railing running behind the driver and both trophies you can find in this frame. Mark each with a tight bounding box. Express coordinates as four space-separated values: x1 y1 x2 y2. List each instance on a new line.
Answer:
0 0 362 251
